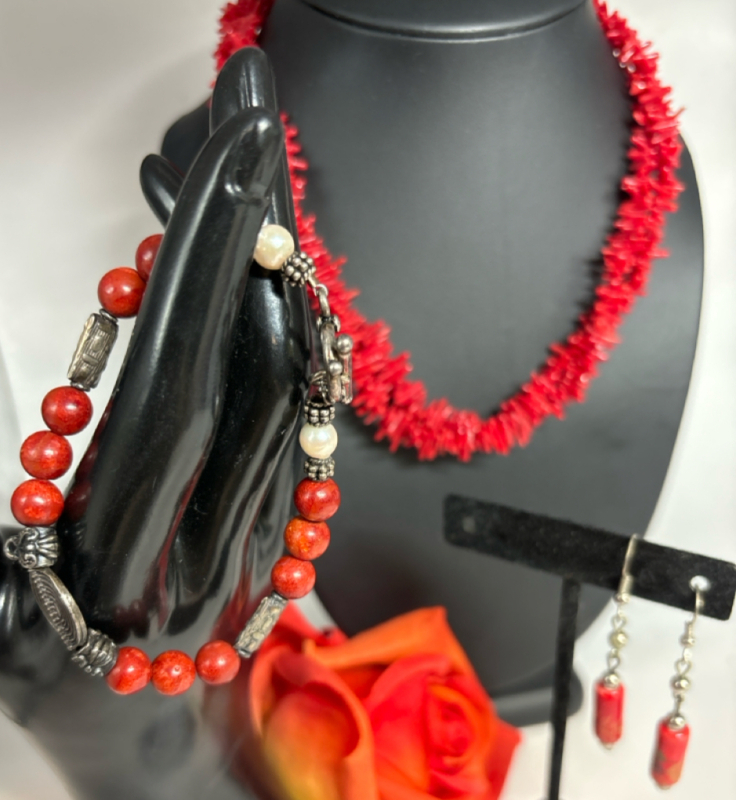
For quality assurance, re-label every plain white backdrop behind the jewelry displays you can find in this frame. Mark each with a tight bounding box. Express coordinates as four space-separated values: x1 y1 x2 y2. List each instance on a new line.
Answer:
0 0 736 800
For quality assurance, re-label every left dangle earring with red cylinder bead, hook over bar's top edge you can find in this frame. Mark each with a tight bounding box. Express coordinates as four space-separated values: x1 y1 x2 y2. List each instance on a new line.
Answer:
595 534 639 750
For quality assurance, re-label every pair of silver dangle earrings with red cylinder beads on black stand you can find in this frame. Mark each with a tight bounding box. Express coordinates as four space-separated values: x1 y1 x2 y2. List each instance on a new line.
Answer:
595 535 710 789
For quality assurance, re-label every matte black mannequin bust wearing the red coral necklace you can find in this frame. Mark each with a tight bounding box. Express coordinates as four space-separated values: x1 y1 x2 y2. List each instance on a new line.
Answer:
254 0 703 722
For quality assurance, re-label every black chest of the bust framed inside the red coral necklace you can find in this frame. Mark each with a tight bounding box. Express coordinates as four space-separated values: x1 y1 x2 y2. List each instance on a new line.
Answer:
263 0 631 414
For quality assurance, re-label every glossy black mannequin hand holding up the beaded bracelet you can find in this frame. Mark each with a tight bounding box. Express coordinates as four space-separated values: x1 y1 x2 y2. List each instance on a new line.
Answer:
0 51 309 800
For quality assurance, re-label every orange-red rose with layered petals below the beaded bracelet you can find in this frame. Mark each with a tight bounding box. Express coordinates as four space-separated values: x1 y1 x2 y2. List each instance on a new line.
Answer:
232 604 520 800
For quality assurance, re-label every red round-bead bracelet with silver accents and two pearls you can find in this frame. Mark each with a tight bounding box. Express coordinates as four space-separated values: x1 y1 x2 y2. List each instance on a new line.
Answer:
3 225 353 695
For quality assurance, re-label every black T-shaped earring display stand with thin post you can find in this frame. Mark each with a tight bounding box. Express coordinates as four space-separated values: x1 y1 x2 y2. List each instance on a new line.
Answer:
444 495 736 800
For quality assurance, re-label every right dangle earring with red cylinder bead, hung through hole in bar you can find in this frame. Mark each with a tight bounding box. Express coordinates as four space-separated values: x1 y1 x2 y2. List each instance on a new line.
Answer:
652 575 710 789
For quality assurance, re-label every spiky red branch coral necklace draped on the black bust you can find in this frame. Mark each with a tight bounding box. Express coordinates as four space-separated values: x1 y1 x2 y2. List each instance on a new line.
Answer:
216 0 682 461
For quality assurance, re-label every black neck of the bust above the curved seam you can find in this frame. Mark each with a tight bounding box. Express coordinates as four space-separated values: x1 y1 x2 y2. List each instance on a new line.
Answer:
304 0 584 39
